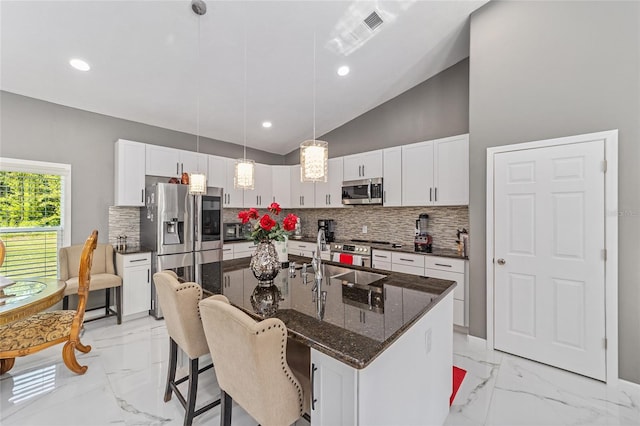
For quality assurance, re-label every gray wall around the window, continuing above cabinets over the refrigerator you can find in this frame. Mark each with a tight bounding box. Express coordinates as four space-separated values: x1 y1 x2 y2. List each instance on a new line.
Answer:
0 92 283 244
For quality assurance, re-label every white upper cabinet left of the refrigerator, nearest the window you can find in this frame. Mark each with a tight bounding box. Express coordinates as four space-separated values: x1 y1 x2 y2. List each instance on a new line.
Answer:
114 139 145 207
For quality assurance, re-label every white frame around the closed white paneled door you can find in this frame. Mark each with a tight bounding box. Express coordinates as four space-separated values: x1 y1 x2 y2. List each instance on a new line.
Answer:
486 129 618 385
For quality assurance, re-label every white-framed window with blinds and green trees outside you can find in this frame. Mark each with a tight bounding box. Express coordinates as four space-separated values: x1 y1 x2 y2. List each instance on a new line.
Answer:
0 158 71 278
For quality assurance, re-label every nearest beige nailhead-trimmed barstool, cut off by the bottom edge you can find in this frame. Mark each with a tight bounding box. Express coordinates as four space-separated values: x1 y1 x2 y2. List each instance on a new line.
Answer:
200 296 308 426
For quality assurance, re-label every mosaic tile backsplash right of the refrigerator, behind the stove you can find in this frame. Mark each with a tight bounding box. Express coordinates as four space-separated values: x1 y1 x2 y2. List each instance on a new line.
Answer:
223 206 470 249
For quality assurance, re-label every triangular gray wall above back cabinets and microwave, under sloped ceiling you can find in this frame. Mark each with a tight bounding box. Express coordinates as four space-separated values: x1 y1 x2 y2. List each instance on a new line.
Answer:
286 59 469 164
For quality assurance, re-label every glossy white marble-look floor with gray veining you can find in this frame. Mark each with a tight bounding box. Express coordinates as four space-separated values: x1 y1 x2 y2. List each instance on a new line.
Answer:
0 317 640 426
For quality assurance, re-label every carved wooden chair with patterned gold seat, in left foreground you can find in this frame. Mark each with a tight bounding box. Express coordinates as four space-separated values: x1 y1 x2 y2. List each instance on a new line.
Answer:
0 230 98 374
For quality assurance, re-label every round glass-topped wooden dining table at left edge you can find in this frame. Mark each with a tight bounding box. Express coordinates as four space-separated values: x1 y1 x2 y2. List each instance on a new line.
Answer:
0 277 66 325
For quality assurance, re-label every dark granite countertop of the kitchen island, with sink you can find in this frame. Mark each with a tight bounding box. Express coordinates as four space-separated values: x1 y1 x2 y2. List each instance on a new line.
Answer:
212 255 456 369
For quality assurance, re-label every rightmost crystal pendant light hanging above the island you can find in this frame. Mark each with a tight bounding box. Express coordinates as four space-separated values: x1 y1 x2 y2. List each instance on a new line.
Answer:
300 32 329 182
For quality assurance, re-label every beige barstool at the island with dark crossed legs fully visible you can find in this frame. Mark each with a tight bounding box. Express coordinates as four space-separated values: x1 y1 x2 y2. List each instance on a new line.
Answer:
153 271 220 426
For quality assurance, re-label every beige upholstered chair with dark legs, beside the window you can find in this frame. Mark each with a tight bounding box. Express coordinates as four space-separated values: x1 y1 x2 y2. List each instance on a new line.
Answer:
58 244 122 324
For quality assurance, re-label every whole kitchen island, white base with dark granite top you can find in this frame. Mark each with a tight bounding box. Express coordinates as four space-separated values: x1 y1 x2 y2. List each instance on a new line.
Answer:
205 255 455 425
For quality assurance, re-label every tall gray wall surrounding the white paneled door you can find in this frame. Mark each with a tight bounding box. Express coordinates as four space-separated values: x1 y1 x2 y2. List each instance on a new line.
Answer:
469 1 640 383
